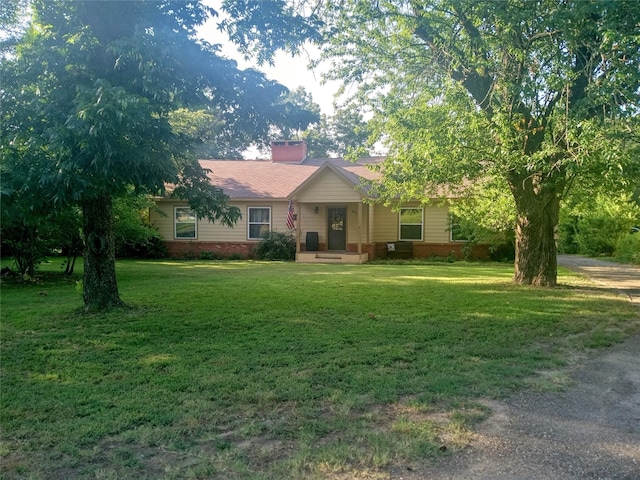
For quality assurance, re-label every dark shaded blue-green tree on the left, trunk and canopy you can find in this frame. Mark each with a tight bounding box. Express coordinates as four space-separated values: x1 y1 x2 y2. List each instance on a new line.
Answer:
1 0 316 309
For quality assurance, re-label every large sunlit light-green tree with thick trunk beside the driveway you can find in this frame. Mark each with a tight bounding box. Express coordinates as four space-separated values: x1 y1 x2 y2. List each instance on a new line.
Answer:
228 0 640 285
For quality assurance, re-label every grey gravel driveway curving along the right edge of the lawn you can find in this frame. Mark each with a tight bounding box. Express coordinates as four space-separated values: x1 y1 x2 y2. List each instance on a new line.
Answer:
391 255 640 480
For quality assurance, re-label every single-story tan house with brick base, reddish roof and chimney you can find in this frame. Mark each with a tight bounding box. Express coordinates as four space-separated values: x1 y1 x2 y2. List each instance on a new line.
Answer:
151 141 488 263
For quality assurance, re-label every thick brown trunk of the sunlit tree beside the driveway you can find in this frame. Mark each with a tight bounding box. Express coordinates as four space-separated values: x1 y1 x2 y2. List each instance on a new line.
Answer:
509 176 560 287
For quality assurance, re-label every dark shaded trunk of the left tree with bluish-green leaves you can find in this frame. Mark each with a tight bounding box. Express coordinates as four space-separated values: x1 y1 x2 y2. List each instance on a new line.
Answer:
82 195 124 311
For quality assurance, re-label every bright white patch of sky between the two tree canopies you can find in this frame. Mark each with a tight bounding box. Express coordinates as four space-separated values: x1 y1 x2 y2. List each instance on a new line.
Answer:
200 0 339 115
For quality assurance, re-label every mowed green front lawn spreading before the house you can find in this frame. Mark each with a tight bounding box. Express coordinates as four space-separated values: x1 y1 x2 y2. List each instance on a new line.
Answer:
0 261 638 479
